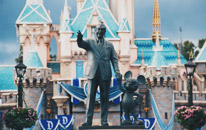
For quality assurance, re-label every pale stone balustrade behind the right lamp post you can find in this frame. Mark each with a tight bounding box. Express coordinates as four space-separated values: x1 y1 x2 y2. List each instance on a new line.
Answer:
173 91 206 106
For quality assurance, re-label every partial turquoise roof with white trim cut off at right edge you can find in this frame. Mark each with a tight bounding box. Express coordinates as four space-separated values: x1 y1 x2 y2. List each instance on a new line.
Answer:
195 42 206 63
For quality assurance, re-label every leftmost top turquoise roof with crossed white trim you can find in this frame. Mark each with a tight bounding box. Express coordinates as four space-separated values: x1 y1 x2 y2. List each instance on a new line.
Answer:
16 0 52 24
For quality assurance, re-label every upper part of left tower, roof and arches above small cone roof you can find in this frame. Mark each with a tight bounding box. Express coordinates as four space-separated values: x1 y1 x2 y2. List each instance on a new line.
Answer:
16 0 52 67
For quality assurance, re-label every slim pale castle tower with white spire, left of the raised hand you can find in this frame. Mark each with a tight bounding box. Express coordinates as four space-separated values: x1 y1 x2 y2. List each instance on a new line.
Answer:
59 0 73 78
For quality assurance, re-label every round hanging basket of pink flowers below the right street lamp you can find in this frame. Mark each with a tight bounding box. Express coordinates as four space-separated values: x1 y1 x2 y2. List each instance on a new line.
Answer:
175 106 206 130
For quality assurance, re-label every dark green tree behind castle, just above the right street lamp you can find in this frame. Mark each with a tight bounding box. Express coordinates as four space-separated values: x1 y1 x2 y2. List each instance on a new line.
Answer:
183 40 195 60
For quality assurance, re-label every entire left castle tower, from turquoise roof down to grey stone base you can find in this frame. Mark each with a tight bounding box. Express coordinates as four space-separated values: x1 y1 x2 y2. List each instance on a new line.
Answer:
14 0 52 123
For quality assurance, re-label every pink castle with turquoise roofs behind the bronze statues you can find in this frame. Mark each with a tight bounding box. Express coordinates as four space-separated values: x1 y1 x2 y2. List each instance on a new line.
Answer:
0 0 206 129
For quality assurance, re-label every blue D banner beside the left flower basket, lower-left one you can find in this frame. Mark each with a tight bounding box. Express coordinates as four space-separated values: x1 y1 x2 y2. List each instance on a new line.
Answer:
39 119 59 130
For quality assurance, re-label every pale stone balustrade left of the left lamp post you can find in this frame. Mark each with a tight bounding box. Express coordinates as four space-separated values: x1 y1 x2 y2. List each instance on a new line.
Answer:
0 91 17 109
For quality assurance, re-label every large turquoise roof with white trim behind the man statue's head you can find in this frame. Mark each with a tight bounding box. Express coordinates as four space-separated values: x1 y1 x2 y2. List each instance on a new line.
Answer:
72 0 119 38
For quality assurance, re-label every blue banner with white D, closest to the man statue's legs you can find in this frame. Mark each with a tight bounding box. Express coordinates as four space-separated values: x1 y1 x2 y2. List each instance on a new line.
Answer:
56 115 74 130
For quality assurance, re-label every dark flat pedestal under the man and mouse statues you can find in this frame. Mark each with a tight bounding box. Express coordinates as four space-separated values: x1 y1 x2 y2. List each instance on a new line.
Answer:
79 125 145 130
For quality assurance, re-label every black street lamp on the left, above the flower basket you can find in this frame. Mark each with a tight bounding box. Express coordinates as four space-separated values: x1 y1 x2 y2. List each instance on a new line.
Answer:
15 57 27 107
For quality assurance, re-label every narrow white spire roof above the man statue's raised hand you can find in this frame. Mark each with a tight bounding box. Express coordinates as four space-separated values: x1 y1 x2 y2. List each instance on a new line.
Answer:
59 0 73 33
